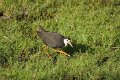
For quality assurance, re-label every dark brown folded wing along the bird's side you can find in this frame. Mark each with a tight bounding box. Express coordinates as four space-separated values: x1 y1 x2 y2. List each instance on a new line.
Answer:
39 32 64 48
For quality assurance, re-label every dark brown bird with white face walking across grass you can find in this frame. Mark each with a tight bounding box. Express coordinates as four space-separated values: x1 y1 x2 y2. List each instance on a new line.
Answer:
37 26 73 56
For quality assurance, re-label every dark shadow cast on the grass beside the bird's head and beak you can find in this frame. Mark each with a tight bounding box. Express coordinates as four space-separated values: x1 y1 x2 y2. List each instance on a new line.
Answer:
63 43 94 55
